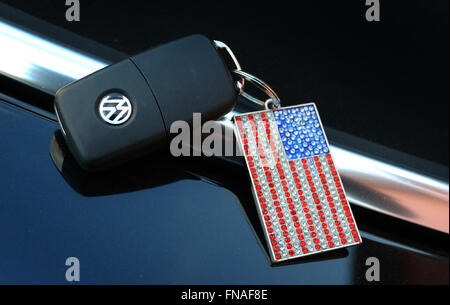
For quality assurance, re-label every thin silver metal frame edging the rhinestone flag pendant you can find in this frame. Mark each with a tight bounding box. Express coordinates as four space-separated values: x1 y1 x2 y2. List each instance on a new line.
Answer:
233 103 362 264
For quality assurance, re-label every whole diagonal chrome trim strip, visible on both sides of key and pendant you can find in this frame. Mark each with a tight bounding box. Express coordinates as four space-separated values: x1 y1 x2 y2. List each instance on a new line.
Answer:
0 19 449 233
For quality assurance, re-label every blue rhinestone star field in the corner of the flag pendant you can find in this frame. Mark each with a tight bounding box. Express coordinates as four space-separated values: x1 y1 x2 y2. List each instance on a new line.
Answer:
273 105 329 160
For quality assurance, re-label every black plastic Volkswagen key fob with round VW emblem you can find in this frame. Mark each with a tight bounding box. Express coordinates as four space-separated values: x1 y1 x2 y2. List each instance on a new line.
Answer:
55 35 237 170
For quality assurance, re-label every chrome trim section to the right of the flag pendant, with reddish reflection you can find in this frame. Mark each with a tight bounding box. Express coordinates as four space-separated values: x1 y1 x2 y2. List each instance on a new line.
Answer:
331 146 449 233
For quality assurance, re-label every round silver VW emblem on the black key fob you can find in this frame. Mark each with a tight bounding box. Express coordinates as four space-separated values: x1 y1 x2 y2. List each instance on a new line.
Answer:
98 93 133 125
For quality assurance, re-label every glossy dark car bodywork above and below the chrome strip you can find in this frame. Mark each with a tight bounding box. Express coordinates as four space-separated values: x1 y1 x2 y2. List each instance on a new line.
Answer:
0 1 449 284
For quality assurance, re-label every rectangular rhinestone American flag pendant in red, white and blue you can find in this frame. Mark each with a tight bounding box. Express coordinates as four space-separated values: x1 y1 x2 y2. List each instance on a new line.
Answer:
234 103 361 262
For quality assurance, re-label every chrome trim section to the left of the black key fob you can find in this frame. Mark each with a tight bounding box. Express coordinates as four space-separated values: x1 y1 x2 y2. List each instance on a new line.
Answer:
0 18 108 94
